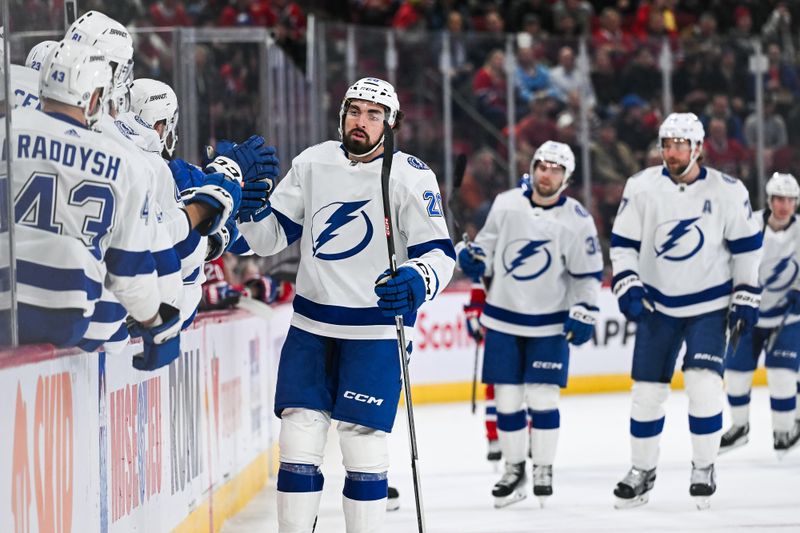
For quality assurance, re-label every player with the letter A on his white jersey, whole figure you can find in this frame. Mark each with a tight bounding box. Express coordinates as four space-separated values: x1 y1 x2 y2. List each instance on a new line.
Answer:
611 113 762 508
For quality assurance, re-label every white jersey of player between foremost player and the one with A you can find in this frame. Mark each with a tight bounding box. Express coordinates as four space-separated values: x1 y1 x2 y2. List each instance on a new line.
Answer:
475 188 603 337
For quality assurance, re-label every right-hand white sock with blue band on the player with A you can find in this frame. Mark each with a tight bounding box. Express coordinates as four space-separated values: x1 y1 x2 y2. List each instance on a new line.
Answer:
683 368 723 468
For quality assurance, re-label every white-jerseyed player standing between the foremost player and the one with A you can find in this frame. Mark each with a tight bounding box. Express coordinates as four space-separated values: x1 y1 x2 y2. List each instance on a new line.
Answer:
458 141 603 507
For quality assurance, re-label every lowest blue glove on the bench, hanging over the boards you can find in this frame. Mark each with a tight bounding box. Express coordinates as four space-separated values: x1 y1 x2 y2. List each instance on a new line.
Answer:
129 303 181 370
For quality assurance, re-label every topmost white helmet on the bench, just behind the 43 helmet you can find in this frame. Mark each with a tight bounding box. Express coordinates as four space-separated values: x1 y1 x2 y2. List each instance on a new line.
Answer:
64 11 133 113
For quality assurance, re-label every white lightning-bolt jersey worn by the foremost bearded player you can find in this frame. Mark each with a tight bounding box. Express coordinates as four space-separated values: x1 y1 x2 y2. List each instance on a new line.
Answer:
239 141 455 339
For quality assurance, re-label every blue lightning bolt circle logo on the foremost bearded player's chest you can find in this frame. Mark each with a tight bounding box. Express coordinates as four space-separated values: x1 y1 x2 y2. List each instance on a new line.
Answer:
311 200 375 261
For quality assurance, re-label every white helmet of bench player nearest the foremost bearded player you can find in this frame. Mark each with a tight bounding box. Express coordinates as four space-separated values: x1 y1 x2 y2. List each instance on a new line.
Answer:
131 78 178 156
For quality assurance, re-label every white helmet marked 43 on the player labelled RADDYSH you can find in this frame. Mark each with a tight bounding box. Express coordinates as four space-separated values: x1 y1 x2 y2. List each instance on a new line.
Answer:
39 41 111 127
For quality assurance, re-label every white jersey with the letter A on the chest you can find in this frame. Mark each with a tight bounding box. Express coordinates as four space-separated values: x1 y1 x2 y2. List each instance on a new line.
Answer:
611 167 762 317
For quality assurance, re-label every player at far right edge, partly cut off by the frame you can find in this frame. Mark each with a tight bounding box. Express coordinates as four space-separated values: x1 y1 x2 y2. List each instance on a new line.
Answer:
720 172 800 456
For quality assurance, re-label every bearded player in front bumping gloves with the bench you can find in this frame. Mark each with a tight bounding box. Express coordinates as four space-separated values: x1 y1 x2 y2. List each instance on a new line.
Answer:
234 78 455 533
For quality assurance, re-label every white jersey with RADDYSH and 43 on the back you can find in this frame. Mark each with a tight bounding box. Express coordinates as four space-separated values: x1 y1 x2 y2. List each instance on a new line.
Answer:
11 108 161 328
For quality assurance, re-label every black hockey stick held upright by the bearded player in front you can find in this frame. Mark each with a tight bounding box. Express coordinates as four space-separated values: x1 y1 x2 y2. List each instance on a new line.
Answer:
381 120 425 533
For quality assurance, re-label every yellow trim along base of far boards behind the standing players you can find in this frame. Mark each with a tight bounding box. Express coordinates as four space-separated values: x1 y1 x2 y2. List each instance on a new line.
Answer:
400 368 767 405
